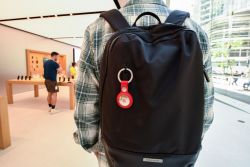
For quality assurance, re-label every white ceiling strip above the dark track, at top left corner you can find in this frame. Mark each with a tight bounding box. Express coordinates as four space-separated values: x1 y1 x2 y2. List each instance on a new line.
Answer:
0 0 114 19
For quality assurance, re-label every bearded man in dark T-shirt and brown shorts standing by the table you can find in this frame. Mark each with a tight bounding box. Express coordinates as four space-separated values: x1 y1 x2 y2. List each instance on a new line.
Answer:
44 52 62 113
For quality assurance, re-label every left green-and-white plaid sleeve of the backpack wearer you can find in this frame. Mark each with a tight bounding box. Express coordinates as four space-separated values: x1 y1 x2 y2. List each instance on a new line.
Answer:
74 25 100 152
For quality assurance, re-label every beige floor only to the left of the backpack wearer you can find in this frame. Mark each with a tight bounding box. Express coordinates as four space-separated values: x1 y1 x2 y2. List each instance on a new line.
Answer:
0 89 98 167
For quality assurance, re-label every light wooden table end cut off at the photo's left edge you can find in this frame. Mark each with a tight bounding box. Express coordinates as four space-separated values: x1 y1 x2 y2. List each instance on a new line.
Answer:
0 96 11 149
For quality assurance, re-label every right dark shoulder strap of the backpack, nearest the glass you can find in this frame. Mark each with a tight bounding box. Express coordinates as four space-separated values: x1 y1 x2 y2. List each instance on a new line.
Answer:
165 10 190 25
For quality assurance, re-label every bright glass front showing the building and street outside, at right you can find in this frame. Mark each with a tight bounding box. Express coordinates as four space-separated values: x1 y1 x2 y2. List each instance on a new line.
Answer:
171 0 250 96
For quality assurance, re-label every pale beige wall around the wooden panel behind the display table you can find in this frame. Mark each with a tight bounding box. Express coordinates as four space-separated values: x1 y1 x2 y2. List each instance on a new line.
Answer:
0 25 73 95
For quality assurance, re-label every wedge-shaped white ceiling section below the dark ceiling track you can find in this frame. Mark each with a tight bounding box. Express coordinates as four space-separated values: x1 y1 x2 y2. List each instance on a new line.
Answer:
3 14 99 46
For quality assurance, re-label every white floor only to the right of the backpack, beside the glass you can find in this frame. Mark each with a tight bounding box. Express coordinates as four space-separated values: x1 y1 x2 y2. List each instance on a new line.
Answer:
196 94 250 167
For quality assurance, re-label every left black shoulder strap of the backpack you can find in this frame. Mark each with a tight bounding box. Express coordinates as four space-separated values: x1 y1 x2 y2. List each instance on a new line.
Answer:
100 9 130 31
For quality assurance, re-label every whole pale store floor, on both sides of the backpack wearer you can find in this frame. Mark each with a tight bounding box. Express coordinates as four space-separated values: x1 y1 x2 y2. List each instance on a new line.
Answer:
0 89 250 167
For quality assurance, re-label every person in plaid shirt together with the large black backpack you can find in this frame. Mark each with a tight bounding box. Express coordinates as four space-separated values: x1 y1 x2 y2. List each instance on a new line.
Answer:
74 0 214 167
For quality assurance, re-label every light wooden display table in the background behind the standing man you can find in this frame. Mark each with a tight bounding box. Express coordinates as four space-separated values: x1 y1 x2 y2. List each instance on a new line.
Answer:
6 79 75 110
